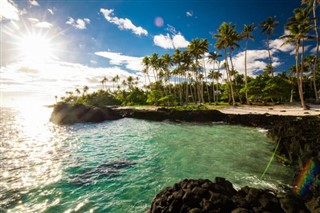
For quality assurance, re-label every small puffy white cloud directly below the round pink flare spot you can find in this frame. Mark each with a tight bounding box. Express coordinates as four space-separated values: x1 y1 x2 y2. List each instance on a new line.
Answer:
153 33 189 49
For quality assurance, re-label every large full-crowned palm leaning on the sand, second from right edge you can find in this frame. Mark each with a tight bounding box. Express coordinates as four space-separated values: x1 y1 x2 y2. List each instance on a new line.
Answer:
280 8 313 109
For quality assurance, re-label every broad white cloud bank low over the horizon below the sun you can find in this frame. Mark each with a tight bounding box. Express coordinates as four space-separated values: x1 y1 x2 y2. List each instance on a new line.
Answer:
0 61 140 104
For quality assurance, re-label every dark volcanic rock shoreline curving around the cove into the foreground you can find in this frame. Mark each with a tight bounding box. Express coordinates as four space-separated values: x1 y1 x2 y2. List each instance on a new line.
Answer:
51 104 320 212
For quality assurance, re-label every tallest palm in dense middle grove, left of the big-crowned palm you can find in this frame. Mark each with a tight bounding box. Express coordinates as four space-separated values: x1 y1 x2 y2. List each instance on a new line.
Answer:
187 38 209 103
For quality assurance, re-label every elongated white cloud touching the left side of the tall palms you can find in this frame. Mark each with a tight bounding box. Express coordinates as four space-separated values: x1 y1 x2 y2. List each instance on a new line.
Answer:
94 51 142 71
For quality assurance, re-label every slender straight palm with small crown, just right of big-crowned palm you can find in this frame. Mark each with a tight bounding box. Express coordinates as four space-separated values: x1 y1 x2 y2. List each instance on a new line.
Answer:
242 24 255 104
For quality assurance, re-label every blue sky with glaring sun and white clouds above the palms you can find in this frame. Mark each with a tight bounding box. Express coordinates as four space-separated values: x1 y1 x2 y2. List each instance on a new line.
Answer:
0 0 314 104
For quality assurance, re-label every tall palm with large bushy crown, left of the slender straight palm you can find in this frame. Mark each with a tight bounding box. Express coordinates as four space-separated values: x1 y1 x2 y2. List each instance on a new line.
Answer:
213 22 239 106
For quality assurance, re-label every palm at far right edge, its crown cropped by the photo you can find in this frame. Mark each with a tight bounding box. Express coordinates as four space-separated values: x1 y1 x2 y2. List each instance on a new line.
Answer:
302 0 320 103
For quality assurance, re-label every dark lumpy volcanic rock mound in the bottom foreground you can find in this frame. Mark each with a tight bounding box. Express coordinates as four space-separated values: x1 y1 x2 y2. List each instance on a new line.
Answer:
149 178 309 213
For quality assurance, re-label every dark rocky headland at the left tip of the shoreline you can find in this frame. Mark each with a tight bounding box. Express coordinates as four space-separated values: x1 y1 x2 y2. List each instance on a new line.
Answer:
50 103 122 124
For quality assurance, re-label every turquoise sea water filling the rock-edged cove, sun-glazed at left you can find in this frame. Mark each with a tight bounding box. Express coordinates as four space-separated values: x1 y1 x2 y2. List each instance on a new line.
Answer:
0 108 292 212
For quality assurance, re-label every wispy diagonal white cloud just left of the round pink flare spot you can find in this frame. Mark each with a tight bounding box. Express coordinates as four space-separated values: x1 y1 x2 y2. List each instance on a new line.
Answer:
100 8 148 36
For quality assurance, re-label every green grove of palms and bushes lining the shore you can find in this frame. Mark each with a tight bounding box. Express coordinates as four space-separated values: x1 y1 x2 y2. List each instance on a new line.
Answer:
61 0 320 109
